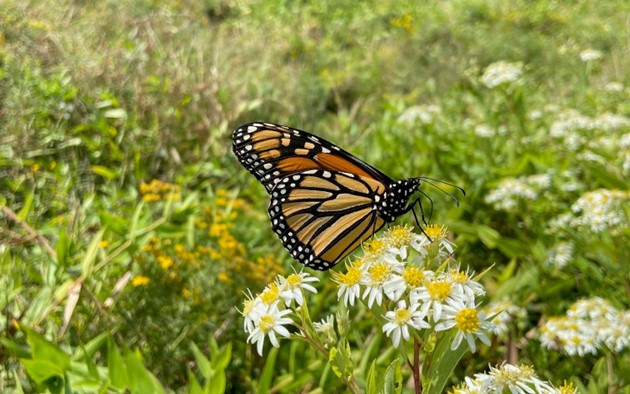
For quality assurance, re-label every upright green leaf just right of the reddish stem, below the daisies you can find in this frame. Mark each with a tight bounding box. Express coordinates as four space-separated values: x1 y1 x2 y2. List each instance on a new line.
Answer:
422 330 468 394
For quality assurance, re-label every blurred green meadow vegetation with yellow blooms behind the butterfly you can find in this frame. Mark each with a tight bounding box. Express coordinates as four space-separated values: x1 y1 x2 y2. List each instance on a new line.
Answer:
0 0 630 393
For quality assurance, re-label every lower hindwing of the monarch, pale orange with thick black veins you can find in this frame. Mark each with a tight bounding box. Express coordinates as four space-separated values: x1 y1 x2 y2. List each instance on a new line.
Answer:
269 170 385 271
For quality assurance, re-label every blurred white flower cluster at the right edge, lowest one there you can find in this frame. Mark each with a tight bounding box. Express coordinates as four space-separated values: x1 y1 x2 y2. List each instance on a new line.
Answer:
540 297 630 357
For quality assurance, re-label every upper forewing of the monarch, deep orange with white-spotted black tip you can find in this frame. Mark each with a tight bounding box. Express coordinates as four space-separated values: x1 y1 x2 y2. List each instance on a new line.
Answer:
232 122 392 193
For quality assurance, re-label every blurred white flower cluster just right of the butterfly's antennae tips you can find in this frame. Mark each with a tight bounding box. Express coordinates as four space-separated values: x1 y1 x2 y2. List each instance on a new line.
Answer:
485 174 551 211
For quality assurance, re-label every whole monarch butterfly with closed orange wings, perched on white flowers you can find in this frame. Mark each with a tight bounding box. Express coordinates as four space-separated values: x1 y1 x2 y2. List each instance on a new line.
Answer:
232 122 465 271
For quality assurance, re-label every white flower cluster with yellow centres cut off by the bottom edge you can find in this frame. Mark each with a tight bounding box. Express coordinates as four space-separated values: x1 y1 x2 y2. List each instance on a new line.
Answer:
450 364 576 394
